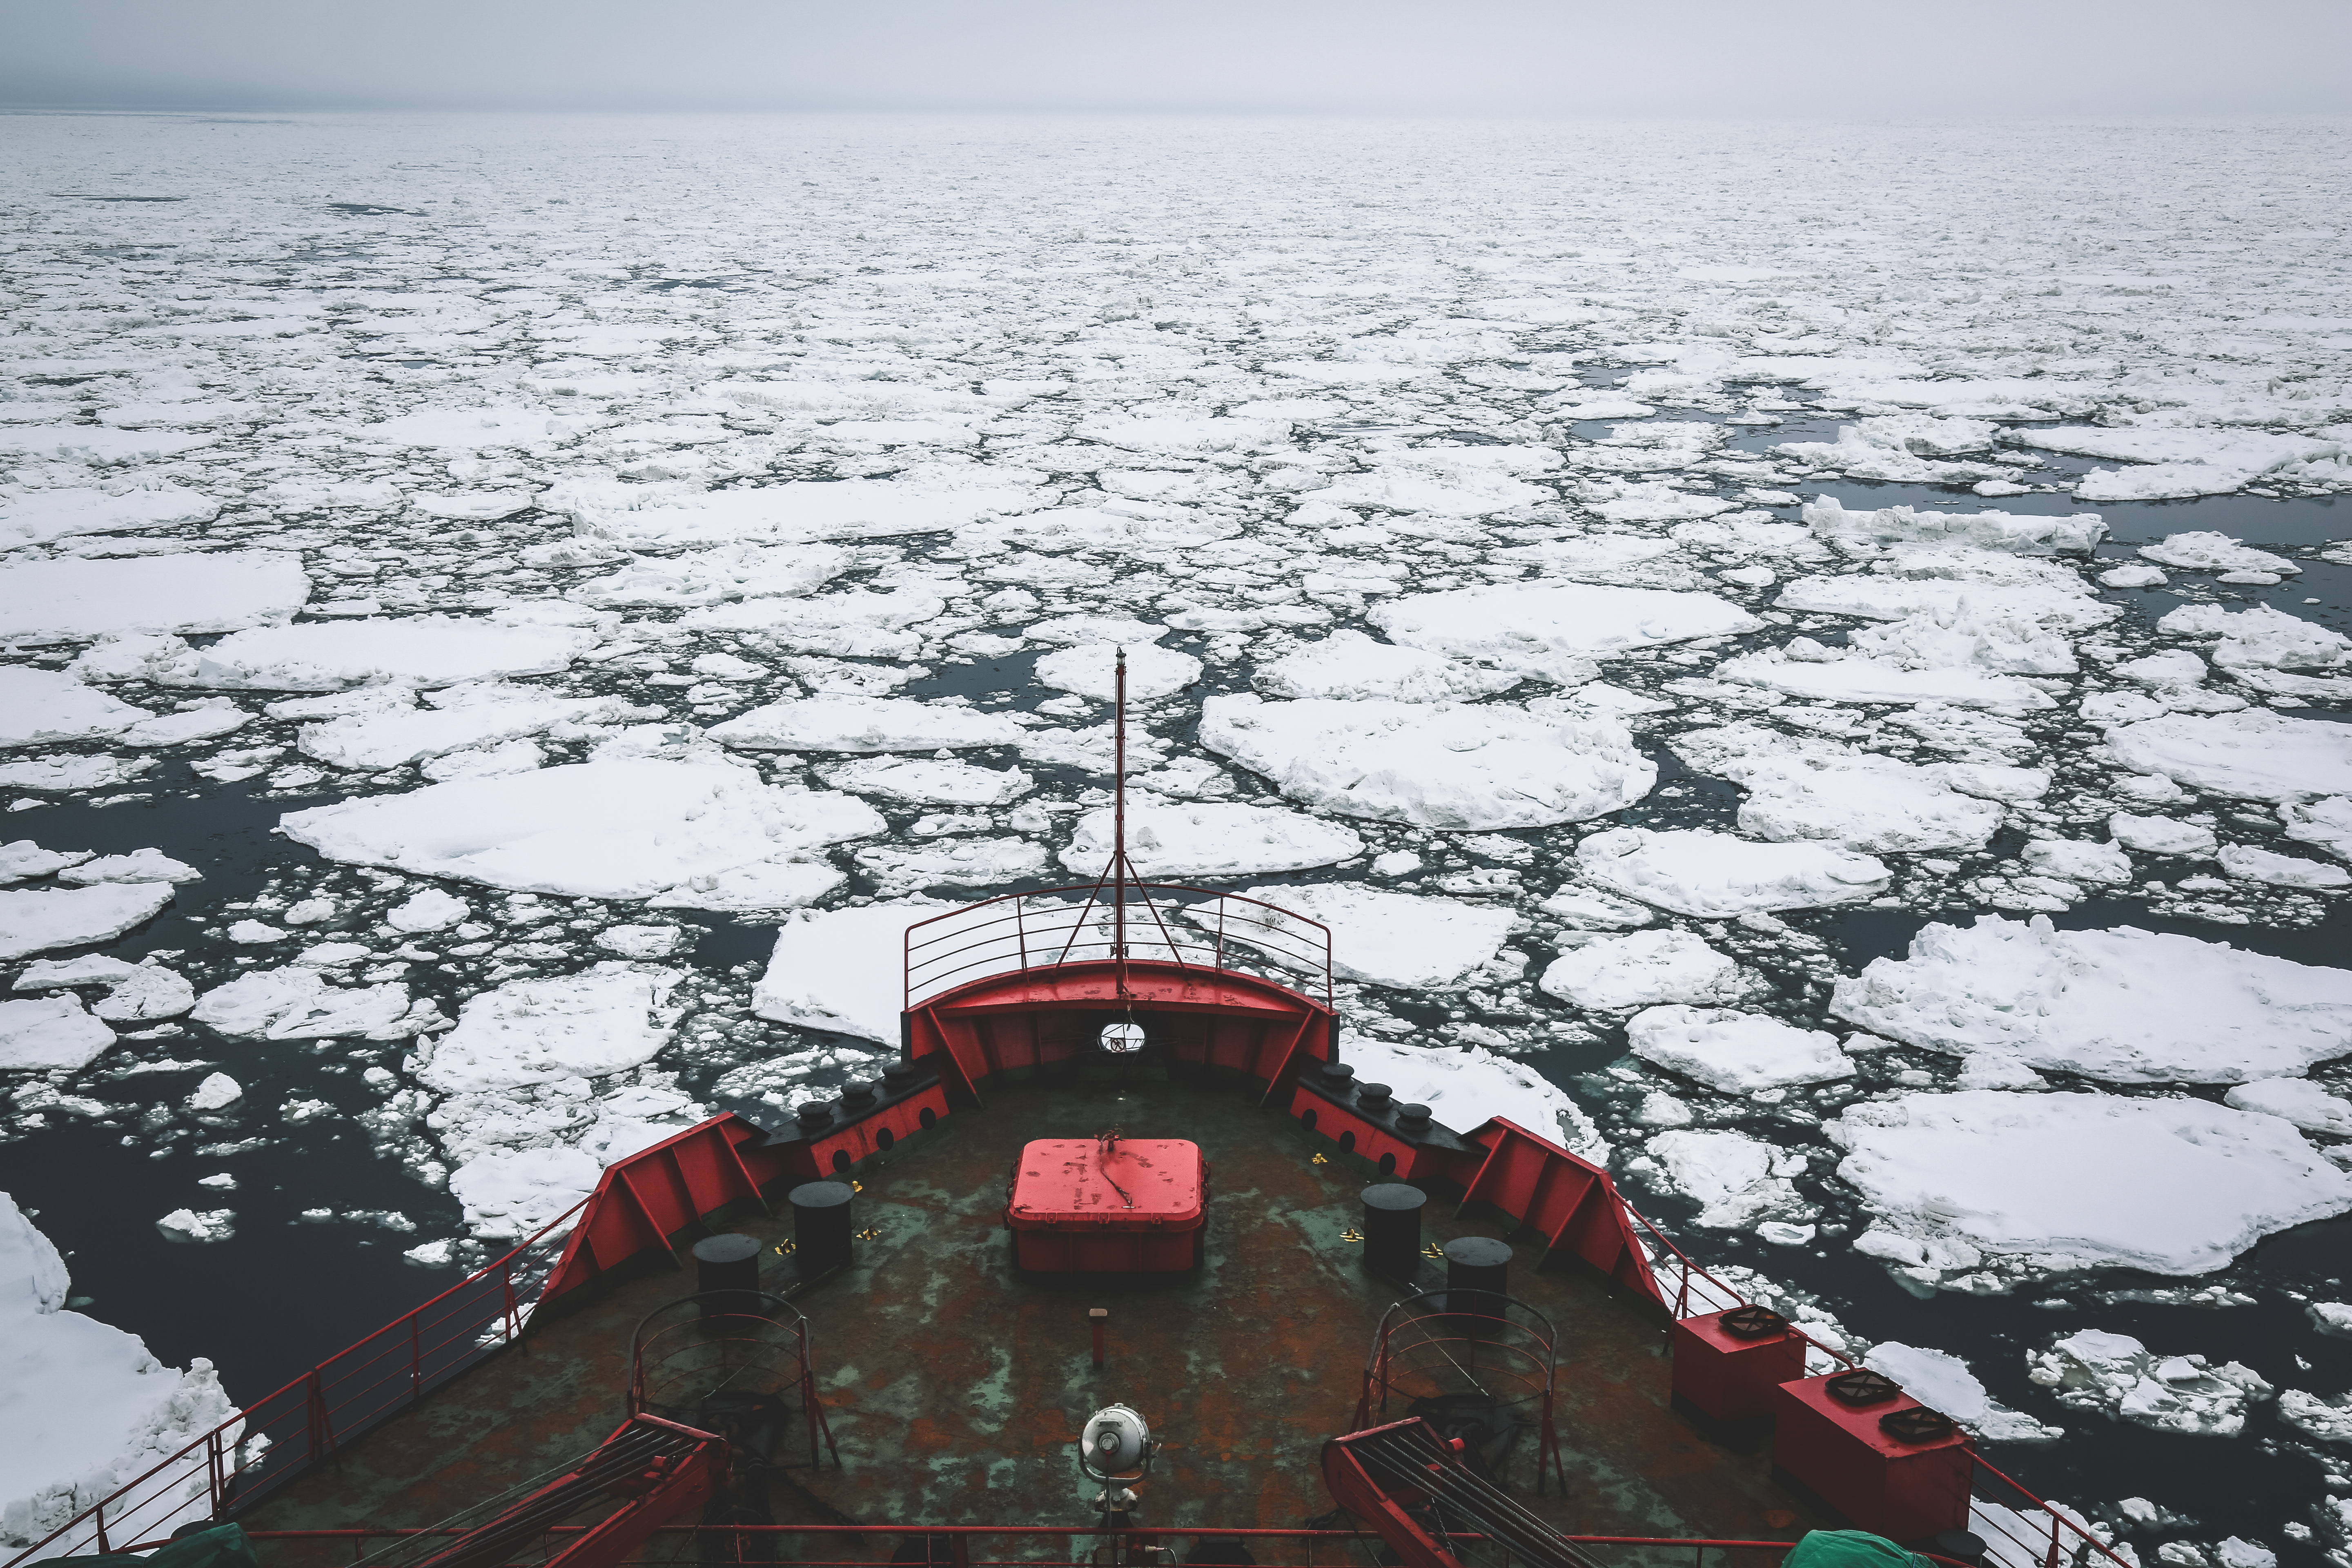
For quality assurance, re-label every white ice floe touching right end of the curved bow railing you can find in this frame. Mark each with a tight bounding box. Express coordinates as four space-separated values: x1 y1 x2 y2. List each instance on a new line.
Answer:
1204 882 1541 992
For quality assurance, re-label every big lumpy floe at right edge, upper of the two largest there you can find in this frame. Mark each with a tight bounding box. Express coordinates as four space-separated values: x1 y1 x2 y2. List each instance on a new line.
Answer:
1830 915 2352 1084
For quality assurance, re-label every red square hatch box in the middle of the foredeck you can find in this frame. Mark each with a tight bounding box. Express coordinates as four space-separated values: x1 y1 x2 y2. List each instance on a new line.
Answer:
1004 1138 1209 1274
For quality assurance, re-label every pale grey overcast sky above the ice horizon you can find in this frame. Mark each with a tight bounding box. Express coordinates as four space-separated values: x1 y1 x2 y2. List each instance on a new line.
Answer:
0 0 2352 118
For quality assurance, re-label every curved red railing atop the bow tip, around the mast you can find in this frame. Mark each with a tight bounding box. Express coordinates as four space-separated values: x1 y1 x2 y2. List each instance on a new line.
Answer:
906 882 1331 1009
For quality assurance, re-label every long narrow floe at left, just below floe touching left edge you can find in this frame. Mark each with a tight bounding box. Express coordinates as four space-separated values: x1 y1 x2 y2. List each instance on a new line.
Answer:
114 616 597 691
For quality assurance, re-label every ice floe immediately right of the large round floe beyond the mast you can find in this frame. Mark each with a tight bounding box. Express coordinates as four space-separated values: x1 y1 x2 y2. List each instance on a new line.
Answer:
1672 722 2002 851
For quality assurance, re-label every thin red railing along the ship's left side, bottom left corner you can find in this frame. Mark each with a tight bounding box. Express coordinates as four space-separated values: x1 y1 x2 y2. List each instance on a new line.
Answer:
7 1199 586 1568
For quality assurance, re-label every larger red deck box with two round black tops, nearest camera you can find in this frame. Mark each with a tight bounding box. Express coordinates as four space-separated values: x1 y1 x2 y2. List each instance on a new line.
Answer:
1771 1378 1976 1542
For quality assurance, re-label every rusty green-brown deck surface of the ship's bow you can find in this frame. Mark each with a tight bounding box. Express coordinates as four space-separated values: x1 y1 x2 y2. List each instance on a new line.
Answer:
242 1081 1813 1561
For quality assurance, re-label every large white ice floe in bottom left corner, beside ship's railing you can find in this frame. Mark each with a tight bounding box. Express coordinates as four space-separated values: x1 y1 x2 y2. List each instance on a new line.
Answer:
0 1192 235 1547
